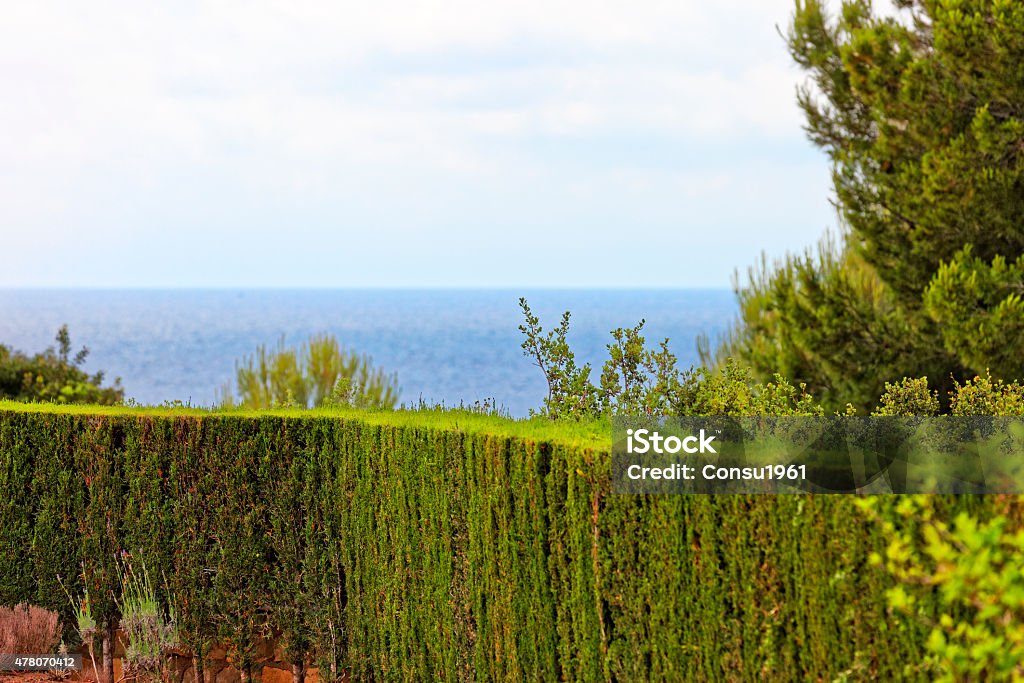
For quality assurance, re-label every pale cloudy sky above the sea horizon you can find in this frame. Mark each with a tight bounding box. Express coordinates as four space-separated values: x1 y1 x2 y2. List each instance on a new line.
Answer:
0 0 836 288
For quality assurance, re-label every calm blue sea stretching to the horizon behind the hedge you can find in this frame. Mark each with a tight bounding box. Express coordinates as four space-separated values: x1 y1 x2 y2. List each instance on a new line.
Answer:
0 290 736 416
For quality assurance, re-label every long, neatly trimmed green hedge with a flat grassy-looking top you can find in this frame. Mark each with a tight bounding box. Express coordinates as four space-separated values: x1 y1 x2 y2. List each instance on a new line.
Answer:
0 403 989 681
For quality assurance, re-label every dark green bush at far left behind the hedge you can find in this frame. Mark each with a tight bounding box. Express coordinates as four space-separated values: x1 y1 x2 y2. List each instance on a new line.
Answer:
0 325 124 405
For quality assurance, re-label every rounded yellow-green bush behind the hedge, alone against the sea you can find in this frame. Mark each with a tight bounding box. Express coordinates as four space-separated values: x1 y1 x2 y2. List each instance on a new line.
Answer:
223 335 398 410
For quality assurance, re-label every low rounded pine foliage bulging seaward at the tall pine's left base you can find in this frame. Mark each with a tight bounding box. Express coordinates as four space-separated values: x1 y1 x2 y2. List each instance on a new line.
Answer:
698 239 948 412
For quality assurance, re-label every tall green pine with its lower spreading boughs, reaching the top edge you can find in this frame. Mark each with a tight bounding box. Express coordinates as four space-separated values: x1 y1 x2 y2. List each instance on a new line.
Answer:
701 0 1024 410
